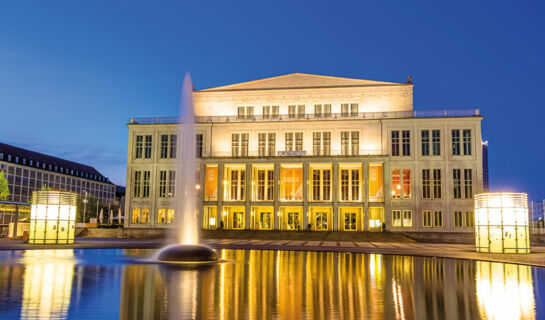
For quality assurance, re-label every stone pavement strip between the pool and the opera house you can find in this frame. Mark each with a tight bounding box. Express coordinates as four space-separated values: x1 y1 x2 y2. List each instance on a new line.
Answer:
0 238 545 267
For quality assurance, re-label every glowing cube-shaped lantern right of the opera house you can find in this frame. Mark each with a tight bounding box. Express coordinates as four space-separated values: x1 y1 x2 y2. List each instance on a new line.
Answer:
475 192 530 253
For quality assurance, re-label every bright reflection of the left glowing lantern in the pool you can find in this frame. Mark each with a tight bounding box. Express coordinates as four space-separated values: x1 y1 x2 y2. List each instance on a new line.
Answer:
21 249 76 319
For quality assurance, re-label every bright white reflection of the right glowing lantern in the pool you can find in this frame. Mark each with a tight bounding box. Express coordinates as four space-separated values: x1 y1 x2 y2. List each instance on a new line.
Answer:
477 261 536 319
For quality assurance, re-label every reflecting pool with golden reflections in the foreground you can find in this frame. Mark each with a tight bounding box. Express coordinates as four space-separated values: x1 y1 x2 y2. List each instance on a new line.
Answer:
0 249 545 319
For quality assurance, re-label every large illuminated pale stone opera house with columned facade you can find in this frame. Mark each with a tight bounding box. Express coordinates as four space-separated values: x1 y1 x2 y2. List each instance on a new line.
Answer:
125 73 483 232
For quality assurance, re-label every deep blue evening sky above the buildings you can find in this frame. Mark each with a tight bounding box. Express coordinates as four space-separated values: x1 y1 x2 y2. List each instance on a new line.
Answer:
0 1 545 199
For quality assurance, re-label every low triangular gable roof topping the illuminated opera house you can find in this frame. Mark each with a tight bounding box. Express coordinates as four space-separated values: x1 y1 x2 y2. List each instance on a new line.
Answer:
197 73 412 92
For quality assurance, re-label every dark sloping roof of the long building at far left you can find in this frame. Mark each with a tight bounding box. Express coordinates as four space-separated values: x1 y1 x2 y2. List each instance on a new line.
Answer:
0 143 111 183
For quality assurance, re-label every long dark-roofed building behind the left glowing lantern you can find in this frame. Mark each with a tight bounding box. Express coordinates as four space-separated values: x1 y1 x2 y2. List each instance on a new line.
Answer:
0 143 115 228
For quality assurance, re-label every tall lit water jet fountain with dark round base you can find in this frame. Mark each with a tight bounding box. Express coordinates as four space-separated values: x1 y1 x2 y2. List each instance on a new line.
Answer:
157 74 218 263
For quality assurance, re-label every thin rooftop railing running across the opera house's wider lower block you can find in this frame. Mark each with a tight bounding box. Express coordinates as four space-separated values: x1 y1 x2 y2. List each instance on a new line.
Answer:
129 109 480 124
